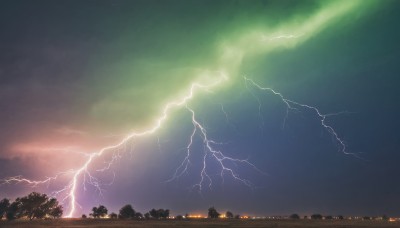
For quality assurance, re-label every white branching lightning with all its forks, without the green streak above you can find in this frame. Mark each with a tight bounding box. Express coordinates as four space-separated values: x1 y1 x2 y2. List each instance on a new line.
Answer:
2 73 358 217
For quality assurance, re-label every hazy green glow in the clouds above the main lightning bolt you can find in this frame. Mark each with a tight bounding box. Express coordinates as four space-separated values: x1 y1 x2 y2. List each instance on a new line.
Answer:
84 1 371 135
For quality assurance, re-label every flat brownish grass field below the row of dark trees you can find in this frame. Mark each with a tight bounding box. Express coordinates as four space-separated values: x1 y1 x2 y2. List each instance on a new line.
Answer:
0 219 400 228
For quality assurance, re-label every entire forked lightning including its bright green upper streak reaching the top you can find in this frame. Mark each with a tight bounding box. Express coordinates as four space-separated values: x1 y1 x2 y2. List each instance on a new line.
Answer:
0 1 370 217
